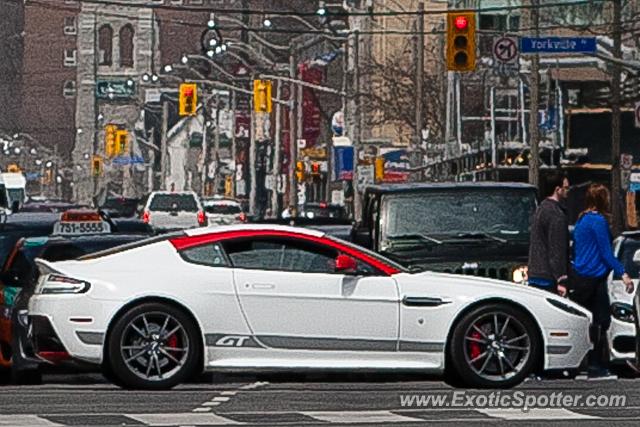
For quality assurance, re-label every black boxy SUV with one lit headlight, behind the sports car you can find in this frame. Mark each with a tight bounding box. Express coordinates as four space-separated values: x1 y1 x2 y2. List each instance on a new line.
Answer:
353 182 536 282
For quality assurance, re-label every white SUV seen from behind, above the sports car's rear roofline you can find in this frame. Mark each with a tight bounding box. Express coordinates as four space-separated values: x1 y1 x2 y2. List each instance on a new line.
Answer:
142 191 207 232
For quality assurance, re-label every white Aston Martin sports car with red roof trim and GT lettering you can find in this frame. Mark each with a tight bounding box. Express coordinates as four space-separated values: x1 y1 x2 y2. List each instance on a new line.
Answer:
29 225 591 389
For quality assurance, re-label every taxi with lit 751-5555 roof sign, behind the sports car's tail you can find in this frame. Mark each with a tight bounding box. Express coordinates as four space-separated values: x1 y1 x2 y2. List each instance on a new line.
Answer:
0 209 150 383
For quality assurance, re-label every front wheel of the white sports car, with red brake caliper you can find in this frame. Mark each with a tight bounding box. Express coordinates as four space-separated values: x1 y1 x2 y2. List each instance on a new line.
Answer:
449 304 541 388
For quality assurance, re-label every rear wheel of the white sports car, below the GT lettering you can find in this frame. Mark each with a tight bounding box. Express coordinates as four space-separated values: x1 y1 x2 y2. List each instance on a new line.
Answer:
106 303 202 390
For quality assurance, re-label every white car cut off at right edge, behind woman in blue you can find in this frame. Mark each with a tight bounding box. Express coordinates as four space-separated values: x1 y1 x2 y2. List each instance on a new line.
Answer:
607 231 640 364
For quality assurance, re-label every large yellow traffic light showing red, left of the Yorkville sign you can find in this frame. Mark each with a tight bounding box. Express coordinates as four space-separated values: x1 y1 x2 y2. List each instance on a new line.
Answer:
447 12 476 71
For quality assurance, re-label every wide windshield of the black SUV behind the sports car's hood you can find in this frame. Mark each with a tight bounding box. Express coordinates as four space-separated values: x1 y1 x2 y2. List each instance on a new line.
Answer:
384 188 536 238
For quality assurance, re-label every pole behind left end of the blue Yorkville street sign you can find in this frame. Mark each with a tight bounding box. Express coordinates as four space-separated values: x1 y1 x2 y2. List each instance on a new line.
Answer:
529 0 540 189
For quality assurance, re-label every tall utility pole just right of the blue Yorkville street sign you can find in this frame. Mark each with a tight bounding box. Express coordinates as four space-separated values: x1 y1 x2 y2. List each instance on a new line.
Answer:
611 0 623 236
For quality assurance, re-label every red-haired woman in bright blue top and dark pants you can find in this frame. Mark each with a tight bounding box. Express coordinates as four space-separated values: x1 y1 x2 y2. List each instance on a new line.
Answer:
572 184 633 377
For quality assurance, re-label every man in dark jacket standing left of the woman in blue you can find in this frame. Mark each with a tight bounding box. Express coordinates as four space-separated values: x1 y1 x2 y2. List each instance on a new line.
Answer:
528 172 569 296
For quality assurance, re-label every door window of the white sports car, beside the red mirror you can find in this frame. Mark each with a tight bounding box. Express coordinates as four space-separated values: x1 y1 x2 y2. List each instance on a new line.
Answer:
225 238 338 273
